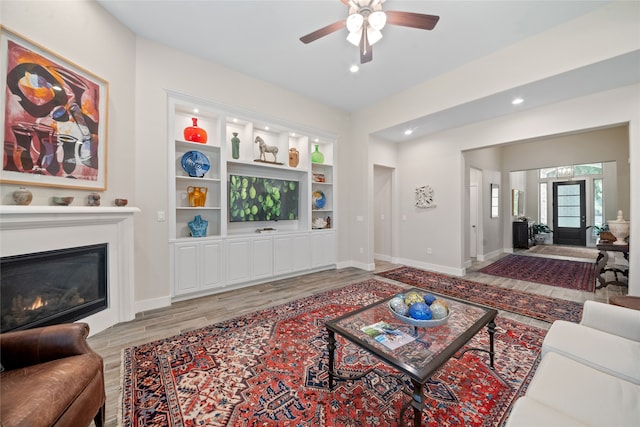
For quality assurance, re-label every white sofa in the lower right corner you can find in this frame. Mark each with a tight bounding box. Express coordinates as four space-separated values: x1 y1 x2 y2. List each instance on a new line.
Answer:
505 301 640 427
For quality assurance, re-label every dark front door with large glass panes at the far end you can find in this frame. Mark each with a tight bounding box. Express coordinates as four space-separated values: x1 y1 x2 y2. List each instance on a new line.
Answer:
553 181 587 246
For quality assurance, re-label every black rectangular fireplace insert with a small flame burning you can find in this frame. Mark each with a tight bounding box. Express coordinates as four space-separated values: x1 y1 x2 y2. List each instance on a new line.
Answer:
0 243 108 332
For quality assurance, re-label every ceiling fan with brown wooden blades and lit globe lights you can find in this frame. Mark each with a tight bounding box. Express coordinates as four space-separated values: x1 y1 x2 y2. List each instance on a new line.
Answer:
300 0 440 64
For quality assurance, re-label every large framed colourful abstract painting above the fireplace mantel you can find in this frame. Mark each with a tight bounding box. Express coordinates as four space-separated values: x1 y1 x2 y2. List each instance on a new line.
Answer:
0 26 109 191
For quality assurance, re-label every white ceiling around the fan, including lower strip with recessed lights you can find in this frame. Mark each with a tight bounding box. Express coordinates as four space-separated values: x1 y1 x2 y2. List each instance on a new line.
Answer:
97 0 640 141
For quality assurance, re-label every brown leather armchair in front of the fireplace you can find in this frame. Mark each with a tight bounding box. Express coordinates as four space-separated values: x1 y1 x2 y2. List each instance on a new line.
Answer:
0 323 105 427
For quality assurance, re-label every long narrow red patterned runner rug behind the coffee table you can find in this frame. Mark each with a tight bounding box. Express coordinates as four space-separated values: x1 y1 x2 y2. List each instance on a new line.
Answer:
376 268 582 323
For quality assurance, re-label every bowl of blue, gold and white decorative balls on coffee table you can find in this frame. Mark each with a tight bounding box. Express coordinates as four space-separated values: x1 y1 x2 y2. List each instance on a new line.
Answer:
389 291 451 328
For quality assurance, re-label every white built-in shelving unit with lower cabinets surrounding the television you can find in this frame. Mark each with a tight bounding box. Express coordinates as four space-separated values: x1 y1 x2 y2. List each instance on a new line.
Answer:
168 94 338 299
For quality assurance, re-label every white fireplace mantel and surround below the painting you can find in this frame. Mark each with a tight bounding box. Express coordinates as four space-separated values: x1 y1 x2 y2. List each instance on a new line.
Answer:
0 205 140 334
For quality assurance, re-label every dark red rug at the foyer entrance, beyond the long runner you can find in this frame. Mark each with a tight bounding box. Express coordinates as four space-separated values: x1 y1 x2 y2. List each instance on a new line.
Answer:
479 255 596 292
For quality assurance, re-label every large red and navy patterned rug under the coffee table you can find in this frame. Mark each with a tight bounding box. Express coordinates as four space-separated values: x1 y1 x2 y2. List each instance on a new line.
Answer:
119 279 545 427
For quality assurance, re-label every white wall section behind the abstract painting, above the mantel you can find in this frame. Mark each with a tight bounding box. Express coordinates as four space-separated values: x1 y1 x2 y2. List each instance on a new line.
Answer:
0 0 137 206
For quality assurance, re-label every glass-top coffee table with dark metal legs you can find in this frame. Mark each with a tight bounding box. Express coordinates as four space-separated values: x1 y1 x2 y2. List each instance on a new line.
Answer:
325 288 498 427
